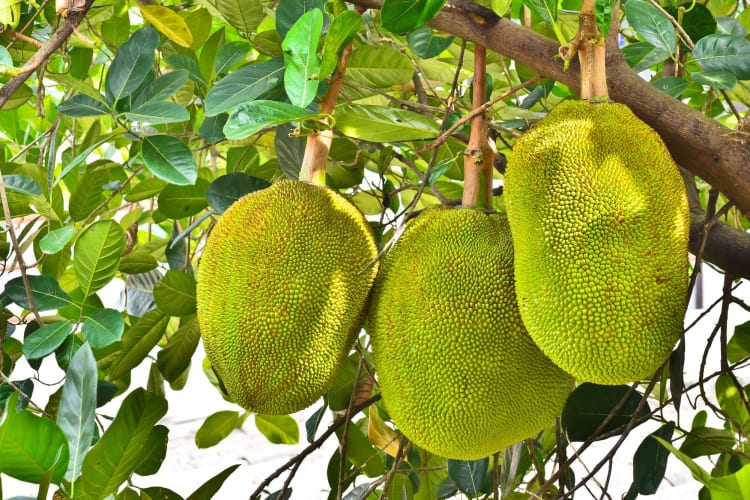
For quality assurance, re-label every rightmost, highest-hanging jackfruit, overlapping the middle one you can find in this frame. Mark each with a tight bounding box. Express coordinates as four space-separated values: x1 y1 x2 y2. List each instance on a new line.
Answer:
504 101 690 384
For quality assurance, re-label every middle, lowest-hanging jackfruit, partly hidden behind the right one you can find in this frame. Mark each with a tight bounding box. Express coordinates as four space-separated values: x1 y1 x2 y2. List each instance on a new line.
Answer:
366 208 572 460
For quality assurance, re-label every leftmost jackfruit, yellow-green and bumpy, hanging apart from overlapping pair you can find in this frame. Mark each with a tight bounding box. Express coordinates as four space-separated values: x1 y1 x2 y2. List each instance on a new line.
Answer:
197 180 377 414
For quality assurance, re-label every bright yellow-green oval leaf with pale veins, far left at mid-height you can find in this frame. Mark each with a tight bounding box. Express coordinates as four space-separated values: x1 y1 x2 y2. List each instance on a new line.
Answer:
73 220 125 297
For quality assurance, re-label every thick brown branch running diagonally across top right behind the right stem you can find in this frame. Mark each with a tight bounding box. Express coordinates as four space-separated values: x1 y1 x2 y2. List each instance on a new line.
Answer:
349 0 750 217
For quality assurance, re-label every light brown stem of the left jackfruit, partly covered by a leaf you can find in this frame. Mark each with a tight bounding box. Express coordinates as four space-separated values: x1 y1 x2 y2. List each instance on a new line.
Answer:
299 44 352 186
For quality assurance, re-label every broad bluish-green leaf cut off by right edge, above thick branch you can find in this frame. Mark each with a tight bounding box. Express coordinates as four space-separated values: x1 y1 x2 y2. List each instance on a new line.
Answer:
693 35 750 80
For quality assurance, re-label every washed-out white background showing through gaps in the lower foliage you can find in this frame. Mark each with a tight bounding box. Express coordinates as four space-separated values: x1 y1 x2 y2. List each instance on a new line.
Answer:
2 273 750 500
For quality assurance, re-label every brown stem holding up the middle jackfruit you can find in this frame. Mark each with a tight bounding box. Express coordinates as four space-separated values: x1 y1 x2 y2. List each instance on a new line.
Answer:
461 45 495 209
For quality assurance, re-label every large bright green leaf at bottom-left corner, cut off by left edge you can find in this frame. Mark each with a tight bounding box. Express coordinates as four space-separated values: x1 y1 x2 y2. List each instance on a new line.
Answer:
0 392 69 484
